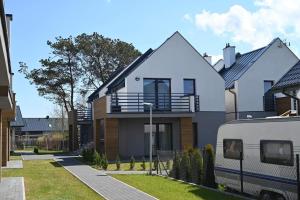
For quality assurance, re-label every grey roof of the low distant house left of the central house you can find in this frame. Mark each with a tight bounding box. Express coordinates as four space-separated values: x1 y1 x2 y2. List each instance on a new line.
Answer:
21 118 68 132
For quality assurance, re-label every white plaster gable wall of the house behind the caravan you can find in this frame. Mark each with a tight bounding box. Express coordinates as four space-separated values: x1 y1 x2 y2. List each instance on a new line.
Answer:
235 39 298 112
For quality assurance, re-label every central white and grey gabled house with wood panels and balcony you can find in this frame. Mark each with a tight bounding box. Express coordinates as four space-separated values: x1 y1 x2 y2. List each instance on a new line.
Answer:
89 32 225 159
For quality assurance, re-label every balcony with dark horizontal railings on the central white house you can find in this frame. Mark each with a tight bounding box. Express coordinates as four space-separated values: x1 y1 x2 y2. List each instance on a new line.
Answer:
108 93 199 113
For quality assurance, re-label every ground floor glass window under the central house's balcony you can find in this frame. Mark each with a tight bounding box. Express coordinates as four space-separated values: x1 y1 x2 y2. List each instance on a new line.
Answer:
144 124 173 155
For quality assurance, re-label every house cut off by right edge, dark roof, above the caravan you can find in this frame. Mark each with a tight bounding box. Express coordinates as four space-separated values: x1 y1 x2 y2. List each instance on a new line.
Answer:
272 61 300 115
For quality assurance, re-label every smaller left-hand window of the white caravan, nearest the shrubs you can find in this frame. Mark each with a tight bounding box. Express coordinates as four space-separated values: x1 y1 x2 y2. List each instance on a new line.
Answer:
223 139 243 160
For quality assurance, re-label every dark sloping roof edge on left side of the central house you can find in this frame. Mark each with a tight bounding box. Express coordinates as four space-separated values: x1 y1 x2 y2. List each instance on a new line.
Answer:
88 49 153 102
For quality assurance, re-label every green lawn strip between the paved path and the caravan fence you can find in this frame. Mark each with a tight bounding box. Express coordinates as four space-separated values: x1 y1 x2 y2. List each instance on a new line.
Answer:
112 175 243 200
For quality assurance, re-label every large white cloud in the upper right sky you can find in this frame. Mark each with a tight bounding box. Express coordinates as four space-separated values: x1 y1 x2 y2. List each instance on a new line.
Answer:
195 0 300 48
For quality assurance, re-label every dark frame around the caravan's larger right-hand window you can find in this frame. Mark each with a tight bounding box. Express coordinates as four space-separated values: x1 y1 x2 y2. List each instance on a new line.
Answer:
260 140 294 166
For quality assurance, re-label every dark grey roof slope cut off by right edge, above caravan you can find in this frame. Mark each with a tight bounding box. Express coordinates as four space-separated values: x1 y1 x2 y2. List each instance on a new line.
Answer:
272 61 300 91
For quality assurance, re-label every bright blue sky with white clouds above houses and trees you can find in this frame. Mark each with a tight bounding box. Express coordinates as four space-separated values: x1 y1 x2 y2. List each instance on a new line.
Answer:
5 0 300 117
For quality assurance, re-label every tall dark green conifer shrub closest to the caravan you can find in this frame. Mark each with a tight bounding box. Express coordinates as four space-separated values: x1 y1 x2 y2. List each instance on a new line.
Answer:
203 144 216 188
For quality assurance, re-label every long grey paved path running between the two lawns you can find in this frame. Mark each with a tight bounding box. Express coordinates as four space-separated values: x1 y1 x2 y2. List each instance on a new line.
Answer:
54 156 156 200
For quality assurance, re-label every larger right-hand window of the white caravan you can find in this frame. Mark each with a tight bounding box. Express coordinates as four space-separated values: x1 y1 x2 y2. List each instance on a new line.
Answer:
260 140 294 166
